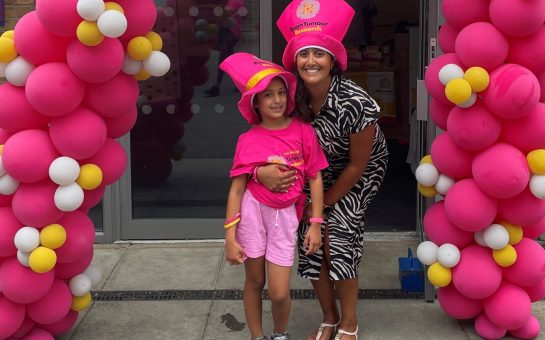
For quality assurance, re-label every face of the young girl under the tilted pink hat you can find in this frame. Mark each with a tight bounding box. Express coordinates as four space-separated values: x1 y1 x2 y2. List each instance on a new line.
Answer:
254 77 288 122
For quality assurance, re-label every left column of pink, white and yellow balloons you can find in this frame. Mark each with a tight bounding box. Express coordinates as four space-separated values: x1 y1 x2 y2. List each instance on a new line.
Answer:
0 0 170 339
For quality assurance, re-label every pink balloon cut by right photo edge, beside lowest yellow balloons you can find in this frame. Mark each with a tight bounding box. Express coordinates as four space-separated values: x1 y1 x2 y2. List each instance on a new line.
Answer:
503 238 545 287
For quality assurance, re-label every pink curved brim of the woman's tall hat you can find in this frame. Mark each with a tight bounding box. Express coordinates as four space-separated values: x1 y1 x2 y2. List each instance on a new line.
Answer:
282 32 348 71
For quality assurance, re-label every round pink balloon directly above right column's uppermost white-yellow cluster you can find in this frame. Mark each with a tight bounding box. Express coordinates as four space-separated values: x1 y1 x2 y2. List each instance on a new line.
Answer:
455 22 509 71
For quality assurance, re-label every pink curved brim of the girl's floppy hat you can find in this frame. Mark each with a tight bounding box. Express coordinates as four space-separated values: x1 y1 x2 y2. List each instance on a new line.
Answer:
238 71 297 124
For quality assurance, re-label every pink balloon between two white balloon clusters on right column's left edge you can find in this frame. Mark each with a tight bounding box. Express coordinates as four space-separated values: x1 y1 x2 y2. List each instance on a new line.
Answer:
423 200 473 249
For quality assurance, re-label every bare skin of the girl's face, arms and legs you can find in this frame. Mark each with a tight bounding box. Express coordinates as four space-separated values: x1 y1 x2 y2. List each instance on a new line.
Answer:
225 78 323 339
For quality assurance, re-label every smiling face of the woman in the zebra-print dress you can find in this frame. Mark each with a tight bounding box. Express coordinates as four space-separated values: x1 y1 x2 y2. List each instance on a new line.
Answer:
296 47 335 85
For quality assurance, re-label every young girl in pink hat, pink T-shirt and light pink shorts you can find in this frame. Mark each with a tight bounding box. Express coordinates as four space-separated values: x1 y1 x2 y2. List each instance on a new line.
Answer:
220 53 328 340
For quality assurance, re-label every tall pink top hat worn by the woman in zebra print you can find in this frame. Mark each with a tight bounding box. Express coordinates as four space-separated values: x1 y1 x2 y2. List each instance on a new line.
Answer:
276 0 354 70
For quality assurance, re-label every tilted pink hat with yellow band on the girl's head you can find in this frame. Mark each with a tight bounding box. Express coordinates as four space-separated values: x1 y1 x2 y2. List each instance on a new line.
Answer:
220 52 297 124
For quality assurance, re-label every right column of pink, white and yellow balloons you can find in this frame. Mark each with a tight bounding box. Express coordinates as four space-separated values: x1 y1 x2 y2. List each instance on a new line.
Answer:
416 0 545 339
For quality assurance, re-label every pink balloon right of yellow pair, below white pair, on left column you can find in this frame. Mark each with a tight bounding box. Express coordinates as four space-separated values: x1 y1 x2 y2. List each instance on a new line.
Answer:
55 210 95 264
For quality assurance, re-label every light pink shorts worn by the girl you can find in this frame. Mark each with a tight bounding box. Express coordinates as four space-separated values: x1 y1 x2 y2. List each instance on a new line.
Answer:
236 190 299 267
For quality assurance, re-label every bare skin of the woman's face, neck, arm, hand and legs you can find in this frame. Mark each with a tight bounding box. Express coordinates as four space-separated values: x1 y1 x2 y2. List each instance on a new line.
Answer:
258 48 376 340
